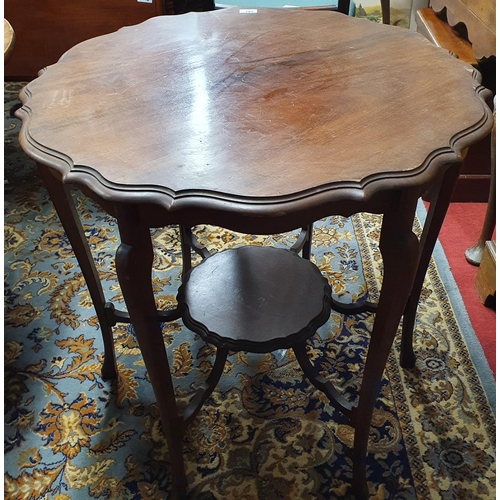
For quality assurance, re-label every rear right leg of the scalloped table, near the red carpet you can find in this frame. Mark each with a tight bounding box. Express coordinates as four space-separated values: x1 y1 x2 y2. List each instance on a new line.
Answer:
400 164 461 368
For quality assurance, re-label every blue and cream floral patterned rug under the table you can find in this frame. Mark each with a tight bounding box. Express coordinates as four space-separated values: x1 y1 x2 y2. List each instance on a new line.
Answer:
4 84 495 500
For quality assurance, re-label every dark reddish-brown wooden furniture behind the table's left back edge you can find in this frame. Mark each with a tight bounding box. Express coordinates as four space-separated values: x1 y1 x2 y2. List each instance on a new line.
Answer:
4 0 170 80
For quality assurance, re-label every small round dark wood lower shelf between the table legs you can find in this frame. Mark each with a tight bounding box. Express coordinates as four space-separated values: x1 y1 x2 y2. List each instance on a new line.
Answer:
177 246 332 352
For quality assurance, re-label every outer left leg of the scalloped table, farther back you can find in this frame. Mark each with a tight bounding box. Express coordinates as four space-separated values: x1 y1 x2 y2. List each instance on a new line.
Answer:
38 164 117 380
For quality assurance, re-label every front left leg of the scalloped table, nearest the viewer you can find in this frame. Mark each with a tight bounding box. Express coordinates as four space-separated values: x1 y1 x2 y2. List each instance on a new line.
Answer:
116 204 187 499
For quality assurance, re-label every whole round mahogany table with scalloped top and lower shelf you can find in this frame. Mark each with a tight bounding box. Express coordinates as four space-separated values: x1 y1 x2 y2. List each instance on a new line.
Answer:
17 8 492 498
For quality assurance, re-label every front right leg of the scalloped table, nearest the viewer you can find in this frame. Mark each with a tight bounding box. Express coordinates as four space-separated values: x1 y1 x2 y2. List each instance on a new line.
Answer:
352 193 418 499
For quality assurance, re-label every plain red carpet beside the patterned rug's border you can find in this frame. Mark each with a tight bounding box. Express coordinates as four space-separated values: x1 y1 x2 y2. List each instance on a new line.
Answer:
439 203 496 374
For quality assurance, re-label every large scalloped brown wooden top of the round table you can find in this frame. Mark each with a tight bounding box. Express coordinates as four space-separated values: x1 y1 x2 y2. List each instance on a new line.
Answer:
18 8 491 205
